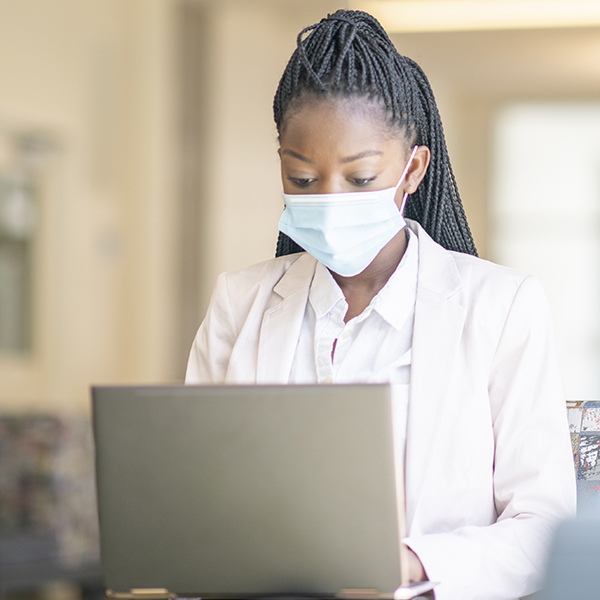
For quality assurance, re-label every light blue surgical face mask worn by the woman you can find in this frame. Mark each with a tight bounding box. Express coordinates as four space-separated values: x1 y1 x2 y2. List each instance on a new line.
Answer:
279 146 418 277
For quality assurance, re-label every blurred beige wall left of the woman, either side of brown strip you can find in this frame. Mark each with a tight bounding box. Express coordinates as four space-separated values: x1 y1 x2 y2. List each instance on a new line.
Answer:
0 0 346 411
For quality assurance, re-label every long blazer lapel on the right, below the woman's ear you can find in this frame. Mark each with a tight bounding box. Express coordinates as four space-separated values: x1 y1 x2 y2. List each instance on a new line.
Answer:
405 224 466 532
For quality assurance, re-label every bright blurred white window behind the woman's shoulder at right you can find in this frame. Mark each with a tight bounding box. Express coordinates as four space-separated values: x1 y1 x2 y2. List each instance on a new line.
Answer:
490 102 600 400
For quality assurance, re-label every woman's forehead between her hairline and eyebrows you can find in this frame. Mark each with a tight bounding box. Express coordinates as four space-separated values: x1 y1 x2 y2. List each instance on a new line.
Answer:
280 98 405 155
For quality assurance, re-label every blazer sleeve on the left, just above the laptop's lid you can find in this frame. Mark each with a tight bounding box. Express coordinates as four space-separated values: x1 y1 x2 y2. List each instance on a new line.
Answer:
185 273 238 385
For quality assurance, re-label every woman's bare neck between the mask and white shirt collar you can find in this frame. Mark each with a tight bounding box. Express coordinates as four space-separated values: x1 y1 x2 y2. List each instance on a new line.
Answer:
331 229 408 322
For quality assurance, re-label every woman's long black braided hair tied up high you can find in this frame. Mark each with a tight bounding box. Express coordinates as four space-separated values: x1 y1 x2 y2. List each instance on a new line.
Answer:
273 10 477 256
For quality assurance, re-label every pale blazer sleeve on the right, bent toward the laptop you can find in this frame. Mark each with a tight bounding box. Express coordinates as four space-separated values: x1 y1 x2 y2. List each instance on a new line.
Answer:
405 277 575 600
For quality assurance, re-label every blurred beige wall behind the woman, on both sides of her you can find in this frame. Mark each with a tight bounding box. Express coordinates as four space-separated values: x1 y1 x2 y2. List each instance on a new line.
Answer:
0 0 600 410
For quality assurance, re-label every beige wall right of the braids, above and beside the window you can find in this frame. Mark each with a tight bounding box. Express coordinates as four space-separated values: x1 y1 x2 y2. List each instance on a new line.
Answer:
393 27 600 258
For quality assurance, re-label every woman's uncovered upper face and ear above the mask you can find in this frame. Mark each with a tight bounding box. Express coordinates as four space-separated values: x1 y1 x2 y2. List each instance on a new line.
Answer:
279 98 430 206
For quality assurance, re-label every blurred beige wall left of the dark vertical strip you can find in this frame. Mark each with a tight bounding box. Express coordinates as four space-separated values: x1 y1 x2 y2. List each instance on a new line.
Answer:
0 0 174 410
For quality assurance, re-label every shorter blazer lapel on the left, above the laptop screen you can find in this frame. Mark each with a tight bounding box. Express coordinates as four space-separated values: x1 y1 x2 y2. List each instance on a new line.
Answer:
256 254 316 383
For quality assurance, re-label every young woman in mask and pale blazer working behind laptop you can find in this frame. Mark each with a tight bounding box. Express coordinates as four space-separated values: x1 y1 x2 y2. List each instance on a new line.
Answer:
187 10 575 600
